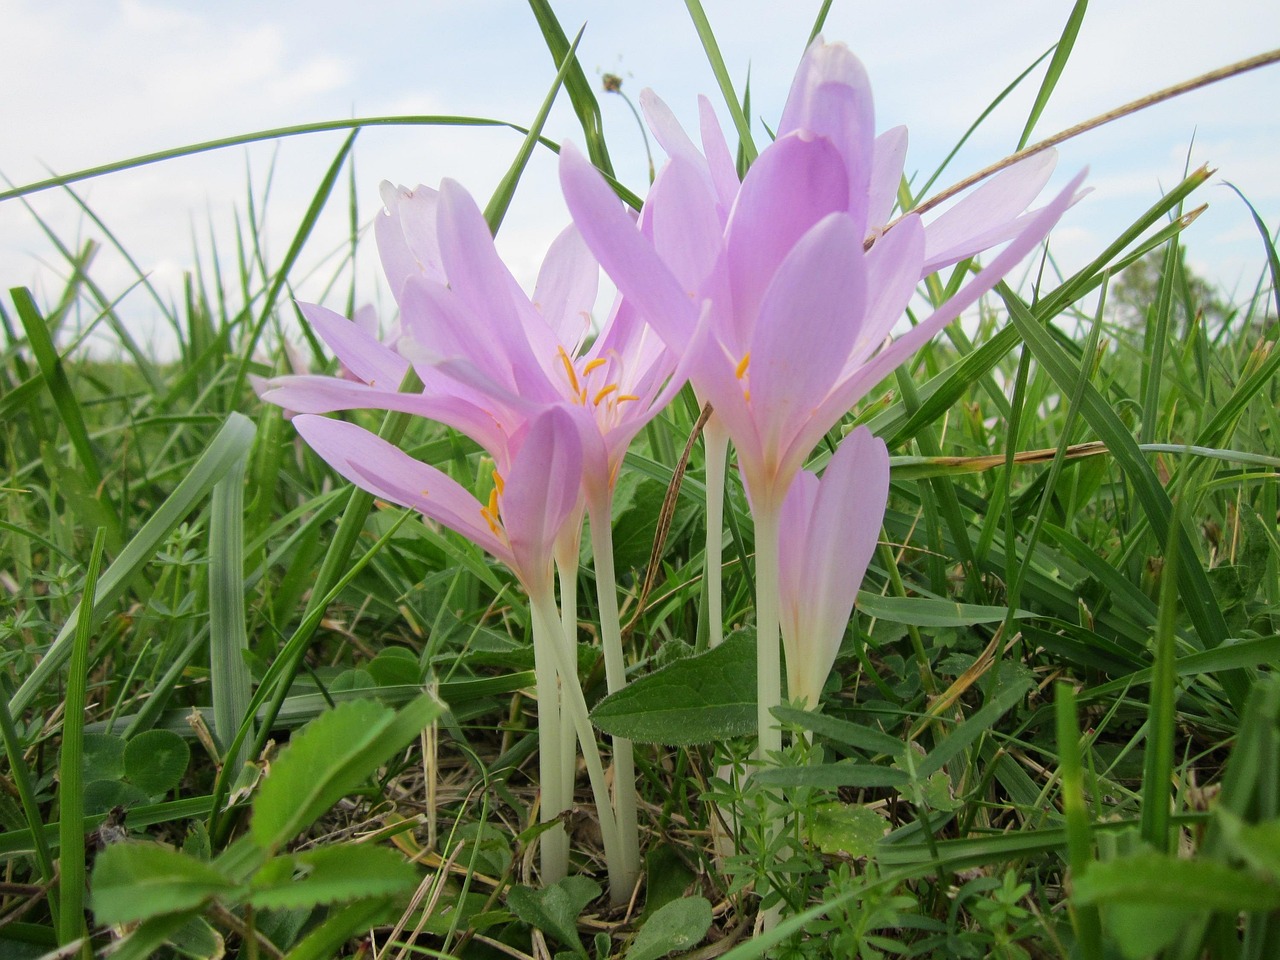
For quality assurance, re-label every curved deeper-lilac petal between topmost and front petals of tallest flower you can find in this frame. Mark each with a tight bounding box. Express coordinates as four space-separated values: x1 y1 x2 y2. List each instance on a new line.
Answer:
726 134 861 339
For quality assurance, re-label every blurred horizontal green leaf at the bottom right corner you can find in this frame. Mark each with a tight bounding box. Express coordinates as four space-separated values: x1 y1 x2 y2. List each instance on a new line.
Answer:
1073 852 1280 913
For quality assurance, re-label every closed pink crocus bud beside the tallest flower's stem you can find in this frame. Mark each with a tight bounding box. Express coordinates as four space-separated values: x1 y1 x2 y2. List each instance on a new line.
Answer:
778 426 888 708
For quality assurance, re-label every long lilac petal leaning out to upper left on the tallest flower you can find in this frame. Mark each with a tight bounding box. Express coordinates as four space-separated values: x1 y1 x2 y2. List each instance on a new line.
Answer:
559 143 699 351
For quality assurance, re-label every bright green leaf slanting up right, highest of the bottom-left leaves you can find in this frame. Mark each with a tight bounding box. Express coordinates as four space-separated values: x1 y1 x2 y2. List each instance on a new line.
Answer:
250 695 442 850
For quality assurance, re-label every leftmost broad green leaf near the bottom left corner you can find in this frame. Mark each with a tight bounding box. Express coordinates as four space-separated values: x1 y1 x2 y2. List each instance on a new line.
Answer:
90 842 236 923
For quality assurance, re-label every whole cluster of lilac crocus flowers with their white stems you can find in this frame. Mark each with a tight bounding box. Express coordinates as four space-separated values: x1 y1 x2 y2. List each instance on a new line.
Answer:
262 32 1080 899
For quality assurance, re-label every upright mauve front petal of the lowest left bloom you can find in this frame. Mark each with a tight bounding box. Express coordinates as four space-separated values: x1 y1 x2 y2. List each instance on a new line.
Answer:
499 407 582 589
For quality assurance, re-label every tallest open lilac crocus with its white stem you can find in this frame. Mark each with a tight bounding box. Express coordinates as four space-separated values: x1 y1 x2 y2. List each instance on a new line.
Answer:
561 41 1083 755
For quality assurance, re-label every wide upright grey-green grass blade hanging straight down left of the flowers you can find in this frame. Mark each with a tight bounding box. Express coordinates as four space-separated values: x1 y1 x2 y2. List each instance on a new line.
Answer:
209 451 252 769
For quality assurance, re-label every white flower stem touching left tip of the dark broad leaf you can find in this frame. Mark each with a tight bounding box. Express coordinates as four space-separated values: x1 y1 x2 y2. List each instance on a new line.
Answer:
591 504 640 888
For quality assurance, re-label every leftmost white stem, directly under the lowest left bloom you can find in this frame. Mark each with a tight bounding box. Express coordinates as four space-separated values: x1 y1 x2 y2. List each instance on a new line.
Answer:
530 598 572 883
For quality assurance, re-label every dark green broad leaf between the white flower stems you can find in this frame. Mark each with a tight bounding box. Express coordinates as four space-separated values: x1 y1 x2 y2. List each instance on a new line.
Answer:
591 634 756 746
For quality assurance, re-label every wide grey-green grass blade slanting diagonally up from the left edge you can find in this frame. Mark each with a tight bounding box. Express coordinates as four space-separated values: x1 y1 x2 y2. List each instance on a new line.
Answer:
9 413 253 716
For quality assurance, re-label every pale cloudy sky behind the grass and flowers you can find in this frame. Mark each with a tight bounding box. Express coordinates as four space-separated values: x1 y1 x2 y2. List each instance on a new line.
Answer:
0 0 1280 358
